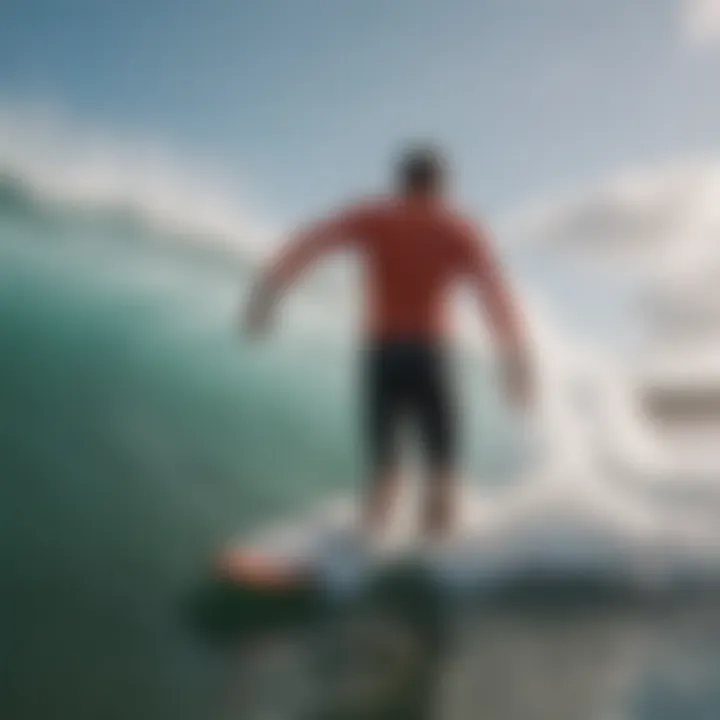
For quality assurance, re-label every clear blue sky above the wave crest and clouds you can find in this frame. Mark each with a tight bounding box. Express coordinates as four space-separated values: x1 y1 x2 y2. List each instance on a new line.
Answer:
0 0 720 221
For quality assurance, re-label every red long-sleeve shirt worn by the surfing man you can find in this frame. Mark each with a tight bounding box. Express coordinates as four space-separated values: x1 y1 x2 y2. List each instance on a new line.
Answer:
270 197 519 346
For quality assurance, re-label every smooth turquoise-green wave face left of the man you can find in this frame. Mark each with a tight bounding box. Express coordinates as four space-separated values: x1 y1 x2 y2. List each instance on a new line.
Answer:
0 180 507 720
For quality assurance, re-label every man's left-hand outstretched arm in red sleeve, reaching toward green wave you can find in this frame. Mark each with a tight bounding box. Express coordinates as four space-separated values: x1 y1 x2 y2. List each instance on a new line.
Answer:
245 213 358 334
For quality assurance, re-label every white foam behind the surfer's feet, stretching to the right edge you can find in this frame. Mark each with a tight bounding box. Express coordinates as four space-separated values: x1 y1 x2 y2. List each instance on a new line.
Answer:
242 464 720 584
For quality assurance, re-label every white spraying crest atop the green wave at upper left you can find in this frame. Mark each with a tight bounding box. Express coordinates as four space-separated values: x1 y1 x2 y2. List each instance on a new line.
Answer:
0 106 277 257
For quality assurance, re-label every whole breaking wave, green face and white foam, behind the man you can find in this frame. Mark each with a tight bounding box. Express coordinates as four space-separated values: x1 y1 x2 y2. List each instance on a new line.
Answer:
0 104 720 720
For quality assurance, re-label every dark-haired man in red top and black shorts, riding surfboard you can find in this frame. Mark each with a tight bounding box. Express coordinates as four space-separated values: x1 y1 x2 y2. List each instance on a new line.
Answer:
245 147 531 536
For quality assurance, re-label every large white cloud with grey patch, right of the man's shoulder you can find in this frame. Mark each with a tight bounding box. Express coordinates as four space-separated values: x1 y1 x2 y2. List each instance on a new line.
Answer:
505 162 720 348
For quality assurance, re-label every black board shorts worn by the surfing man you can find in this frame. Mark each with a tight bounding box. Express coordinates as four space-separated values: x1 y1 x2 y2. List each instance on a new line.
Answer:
364 340 456 472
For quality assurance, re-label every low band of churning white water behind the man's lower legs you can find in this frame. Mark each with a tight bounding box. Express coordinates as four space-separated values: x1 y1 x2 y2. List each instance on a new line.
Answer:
231 472 720 601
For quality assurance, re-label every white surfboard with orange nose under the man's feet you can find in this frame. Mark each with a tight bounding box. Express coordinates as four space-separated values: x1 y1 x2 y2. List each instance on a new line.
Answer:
191 490 492 635
